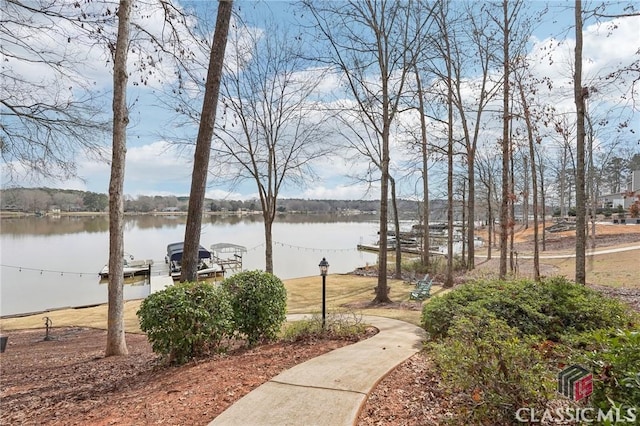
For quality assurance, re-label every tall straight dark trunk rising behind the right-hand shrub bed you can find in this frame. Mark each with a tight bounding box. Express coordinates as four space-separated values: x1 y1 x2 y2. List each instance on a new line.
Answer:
573 0 588 285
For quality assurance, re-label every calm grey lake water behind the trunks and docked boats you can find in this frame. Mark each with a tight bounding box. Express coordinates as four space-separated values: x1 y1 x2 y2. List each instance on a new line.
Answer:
0 215 378 316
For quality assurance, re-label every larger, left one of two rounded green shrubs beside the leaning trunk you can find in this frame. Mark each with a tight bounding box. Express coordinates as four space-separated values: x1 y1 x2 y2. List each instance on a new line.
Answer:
137 282 233 364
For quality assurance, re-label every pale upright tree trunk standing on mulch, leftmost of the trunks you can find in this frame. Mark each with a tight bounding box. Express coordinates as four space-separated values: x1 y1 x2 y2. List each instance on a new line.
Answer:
105 0 131 356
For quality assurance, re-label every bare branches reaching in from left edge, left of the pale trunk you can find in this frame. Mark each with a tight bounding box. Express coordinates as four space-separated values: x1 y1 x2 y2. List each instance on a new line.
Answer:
0 0 113 181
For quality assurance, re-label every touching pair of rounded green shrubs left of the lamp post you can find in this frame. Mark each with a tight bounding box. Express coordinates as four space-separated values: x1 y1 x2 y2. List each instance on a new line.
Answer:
137 271 287 363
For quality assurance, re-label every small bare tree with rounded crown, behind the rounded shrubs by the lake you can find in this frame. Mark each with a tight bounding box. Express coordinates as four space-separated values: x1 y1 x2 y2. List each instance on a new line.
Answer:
214 18 329 272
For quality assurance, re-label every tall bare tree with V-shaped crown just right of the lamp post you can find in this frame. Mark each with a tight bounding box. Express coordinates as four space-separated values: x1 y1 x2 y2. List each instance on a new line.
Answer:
304 0 428 303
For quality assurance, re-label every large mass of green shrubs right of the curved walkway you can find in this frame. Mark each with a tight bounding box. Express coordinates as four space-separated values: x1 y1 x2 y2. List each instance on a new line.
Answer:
422 278 640 424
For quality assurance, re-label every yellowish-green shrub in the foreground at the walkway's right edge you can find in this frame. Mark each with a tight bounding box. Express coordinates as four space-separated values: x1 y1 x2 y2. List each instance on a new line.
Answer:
429 311 556 424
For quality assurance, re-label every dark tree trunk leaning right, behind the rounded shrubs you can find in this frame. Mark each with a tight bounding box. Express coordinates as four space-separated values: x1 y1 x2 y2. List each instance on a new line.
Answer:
180 0 233 282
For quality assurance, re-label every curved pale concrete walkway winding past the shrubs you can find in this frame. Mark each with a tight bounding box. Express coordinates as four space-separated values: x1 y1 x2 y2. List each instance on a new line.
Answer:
210 316 426 426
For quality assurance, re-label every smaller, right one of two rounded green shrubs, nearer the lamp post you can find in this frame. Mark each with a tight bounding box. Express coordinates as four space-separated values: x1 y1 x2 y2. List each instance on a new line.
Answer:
222 271 287 345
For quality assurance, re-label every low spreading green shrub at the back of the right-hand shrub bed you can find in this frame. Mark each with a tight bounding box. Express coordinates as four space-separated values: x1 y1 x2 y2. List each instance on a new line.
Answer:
422 278 629 340
